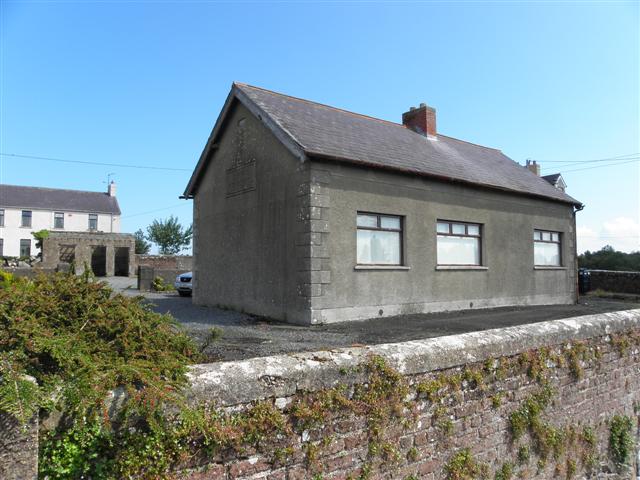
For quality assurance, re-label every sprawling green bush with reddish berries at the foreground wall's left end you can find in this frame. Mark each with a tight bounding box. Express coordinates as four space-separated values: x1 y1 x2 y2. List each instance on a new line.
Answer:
0 273 198 479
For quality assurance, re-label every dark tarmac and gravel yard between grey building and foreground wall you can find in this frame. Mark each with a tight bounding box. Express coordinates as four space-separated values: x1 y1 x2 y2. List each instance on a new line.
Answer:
108 278 640 361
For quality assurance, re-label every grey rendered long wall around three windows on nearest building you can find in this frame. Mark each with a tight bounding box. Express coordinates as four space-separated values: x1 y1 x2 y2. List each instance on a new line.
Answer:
312 163 576 323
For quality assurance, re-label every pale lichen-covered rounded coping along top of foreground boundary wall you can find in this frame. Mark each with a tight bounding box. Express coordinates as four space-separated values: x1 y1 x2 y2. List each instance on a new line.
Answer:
189 309 640 407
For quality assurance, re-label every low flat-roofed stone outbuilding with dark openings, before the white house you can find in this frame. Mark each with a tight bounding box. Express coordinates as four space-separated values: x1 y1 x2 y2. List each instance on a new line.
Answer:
40 232 136 277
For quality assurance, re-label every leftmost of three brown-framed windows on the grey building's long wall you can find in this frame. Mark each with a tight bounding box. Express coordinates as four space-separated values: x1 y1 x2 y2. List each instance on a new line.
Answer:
357 213 402 265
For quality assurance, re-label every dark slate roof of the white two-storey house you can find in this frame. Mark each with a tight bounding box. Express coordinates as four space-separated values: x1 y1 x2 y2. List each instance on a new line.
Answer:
0 185 120 215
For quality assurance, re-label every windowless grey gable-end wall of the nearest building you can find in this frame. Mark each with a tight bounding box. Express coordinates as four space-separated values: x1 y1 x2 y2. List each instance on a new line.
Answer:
193 103 310 323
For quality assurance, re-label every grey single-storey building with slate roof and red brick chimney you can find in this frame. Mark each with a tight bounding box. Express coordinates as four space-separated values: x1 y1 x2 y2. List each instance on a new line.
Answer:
184 83 582 325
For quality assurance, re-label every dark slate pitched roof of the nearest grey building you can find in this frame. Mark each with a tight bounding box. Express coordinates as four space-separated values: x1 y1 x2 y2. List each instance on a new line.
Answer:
185 83 580 205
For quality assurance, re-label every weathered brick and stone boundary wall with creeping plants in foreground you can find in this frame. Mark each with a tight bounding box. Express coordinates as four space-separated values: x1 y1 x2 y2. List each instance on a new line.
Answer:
181 310 640 480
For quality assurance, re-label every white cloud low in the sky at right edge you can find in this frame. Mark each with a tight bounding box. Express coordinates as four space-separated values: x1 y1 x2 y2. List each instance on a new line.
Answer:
576 217 640 253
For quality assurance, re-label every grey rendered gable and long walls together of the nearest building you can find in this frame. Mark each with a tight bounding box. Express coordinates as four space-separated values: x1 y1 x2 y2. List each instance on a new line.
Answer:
194 104 576 325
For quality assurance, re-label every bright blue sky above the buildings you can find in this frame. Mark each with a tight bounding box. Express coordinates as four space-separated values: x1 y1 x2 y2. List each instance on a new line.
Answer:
0 0 640 251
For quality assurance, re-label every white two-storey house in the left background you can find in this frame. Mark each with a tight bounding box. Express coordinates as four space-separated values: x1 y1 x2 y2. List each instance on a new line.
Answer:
0 182 120 257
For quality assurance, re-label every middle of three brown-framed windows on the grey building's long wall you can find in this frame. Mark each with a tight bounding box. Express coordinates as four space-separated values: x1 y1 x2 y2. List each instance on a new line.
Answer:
436 220 482 265
